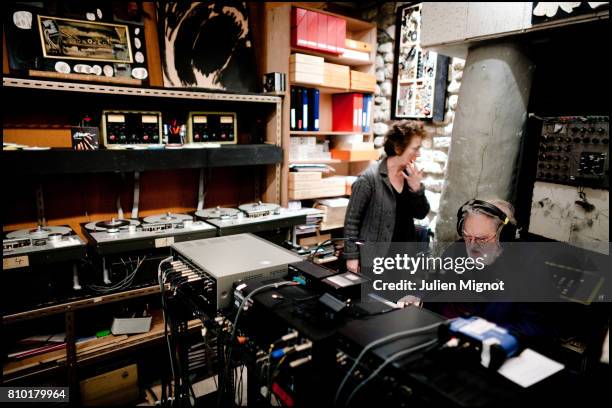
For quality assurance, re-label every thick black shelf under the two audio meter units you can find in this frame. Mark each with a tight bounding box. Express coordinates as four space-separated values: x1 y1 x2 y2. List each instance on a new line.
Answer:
2 144 283 176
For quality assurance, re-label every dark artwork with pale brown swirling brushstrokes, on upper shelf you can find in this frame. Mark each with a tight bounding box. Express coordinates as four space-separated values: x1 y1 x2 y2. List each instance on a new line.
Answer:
155 1 257 92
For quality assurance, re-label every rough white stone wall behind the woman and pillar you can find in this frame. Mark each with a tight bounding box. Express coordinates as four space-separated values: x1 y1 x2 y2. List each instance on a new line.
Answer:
363 2 465 237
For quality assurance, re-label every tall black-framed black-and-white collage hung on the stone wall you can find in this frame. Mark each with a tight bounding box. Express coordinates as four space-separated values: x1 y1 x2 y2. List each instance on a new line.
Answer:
392 4 450 120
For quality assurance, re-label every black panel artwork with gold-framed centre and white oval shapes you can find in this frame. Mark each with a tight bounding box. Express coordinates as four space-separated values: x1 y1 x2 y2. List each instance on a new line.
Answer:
5 2 148 84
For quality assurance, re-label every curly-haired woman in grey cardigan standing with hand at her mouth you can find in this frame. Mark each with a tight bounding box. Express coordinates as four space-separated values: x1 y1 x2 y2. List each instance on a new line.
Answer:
344 120 429 272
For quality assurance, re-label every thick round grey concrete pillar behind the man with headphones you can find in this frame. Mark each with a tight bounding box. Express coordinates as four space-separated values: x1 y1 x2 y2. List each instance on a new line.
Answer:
436 42 534 242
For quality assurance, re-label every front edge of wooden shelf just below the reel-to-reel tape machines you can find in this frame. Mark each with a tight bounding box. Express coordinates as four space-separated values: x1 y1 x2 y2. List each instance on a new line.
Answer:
2 285 159 324
